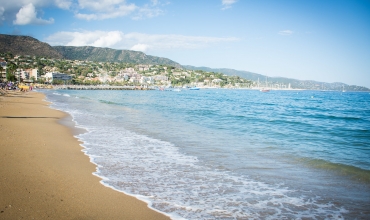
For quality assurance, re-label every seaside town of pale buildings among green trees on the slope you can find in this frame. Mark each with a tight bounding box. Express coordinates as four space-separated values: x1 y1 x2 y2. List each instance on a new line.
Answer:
0 53 254 88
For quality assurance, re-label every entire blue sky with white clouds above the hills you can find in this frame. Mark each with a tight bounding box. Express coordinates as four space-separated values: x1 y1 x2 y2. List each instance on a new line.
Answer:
0 0 370 88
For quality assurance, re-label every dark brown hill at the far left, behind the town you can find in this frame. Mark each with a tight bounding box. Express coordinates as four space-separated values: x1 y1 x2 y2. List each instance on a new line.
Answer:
0 34 63 59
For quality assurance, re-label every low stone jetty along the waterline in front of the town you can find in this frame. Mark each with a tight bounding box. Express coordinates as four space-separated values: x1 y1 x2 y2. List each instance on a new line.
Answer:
54 85 153 90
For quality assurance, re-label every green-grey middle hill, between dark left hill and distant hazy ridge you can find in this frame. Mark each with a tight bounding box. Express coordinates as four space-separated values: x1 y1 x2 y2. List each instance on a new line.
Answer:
53 46 181 67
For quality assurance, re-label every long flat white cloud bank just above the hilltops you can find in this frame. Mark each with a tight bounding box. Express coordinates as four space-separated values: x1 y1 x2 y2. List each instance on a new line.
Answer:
45 31 238 51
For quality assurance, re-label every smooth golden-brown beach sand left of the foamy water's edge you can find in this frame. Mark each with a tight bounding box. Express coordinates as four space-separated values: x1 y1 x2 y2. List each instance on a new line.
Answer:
0 92 169 219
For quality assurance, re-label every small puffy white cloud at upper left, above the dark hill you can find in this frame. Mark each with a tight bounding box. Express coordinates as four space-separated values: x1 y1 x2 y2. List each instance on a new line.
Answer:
13 3 54 25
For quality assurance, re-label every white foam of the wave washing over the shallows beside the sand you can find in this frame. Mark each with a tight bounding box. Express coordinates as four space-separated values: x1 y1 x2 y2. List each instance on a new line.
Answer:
74 125 345 219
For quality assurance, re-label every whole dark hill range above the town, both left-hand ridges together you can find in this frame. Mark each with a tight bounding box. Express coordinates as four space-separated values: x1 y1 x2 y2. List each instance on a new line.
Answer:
0 34 181 68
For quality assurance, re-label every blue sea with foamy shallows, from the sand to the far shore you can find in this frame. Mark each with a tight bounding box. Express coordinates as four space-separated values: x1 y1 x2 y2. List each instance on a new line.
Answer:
39 89 370 219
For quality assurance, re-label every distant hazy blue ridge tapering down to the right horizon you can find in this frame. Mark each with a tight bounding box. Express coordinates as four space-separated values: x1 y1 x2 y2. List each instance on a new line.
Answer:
183 65 370 91
